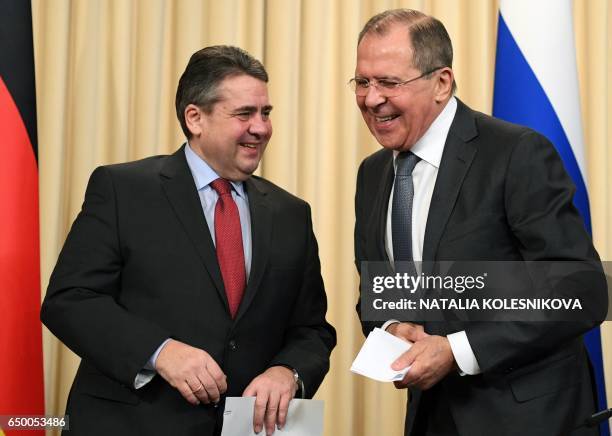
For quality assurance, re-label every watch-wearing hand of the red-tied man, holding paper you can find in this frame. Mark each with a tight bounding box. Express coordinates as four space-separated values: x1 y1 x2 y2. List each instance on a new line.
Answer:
242 366 297 435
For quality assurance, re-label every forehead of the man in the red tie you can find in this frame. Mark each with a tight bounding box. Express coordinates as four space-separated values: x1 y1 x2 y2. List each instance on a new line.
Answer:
218 74 270 107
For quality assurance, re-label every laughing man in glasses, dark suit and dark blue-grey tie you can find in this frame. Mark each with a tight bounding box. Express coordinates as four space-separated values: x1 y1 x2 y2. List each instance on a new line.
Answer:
351 10 607 436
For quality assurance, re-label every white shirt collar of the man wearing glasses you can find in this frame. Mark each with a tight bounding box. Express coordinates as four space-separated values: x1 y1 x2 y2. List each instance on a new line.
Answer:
393 97 457 168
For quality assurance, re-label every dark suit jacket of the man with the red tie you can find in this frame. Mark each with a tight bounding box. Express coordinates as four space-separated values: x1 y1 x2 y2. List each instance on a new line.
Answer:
41 147 336 436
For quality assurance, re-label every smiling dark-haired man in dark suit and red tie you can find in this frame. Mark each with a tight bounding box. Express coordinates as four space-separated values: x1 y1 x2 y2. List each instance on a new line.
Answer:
41 46 336 436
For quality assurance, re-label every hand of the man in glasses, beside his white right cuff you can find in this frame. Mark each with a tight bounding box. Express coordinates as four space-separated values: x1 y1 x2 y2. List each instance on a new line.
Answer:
391 335 456 390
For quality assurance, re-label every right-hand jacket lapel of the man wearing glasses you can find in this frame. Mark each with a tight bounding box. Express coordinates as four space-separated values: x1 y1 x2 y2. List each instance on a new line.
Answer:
423 99 478 261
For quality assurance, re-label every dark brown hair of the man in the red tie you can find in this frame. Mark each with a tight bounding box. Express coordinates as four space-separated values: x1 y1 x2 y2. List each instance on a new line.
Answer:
175 45 268 138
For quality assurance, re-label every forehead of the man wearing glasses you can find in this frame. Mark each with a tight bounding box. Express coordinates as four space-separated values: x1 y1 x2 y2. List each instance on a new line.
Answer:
355 24 414 77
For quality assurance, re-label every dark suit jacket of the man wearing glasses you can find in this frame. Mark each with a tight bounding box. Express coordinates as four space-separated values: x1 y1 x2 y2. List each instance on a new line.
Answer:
355 101 607 436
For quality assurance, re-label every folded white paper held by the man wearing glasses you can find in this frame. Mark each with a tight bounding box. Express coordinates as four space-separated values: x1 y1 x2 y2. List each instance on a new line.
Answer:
351 328 412 382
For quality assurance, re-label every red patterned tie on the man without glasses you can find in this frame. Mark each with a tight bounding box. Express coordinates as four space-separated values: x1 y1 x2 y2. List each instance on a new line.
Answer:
210 179 246 318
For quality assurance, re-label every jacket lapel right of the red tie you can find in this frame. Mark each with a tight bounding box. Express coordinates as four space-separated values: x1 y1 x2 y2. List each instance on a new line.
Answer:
236 177 272 321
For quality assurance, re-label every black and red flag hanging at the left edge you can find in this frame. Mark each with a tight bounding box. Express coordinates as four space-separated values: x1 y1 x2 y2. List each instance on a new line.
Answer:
0 0 44 436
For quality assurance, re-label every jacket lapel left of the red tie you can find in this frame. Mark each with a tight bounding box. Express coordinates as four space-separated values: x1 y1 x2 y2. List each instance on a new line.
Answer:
160 146 229 314
